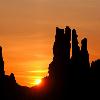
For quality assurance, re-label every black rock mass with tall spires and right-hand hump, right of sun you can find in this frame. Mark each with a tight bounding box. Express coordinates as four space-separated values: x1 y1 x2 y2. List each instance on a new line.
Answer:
44 26 100 100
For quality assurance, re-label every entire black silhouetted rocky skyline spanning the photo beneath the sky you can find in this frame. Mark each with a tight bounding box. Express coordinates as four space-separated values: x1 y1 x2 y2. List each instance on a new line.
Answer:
0 26 100 100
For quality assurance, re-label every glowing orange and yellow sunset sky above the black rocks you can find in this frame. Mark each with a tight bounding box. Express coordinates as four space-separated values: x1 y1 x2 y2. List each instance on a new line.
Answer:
0 0 100 86
